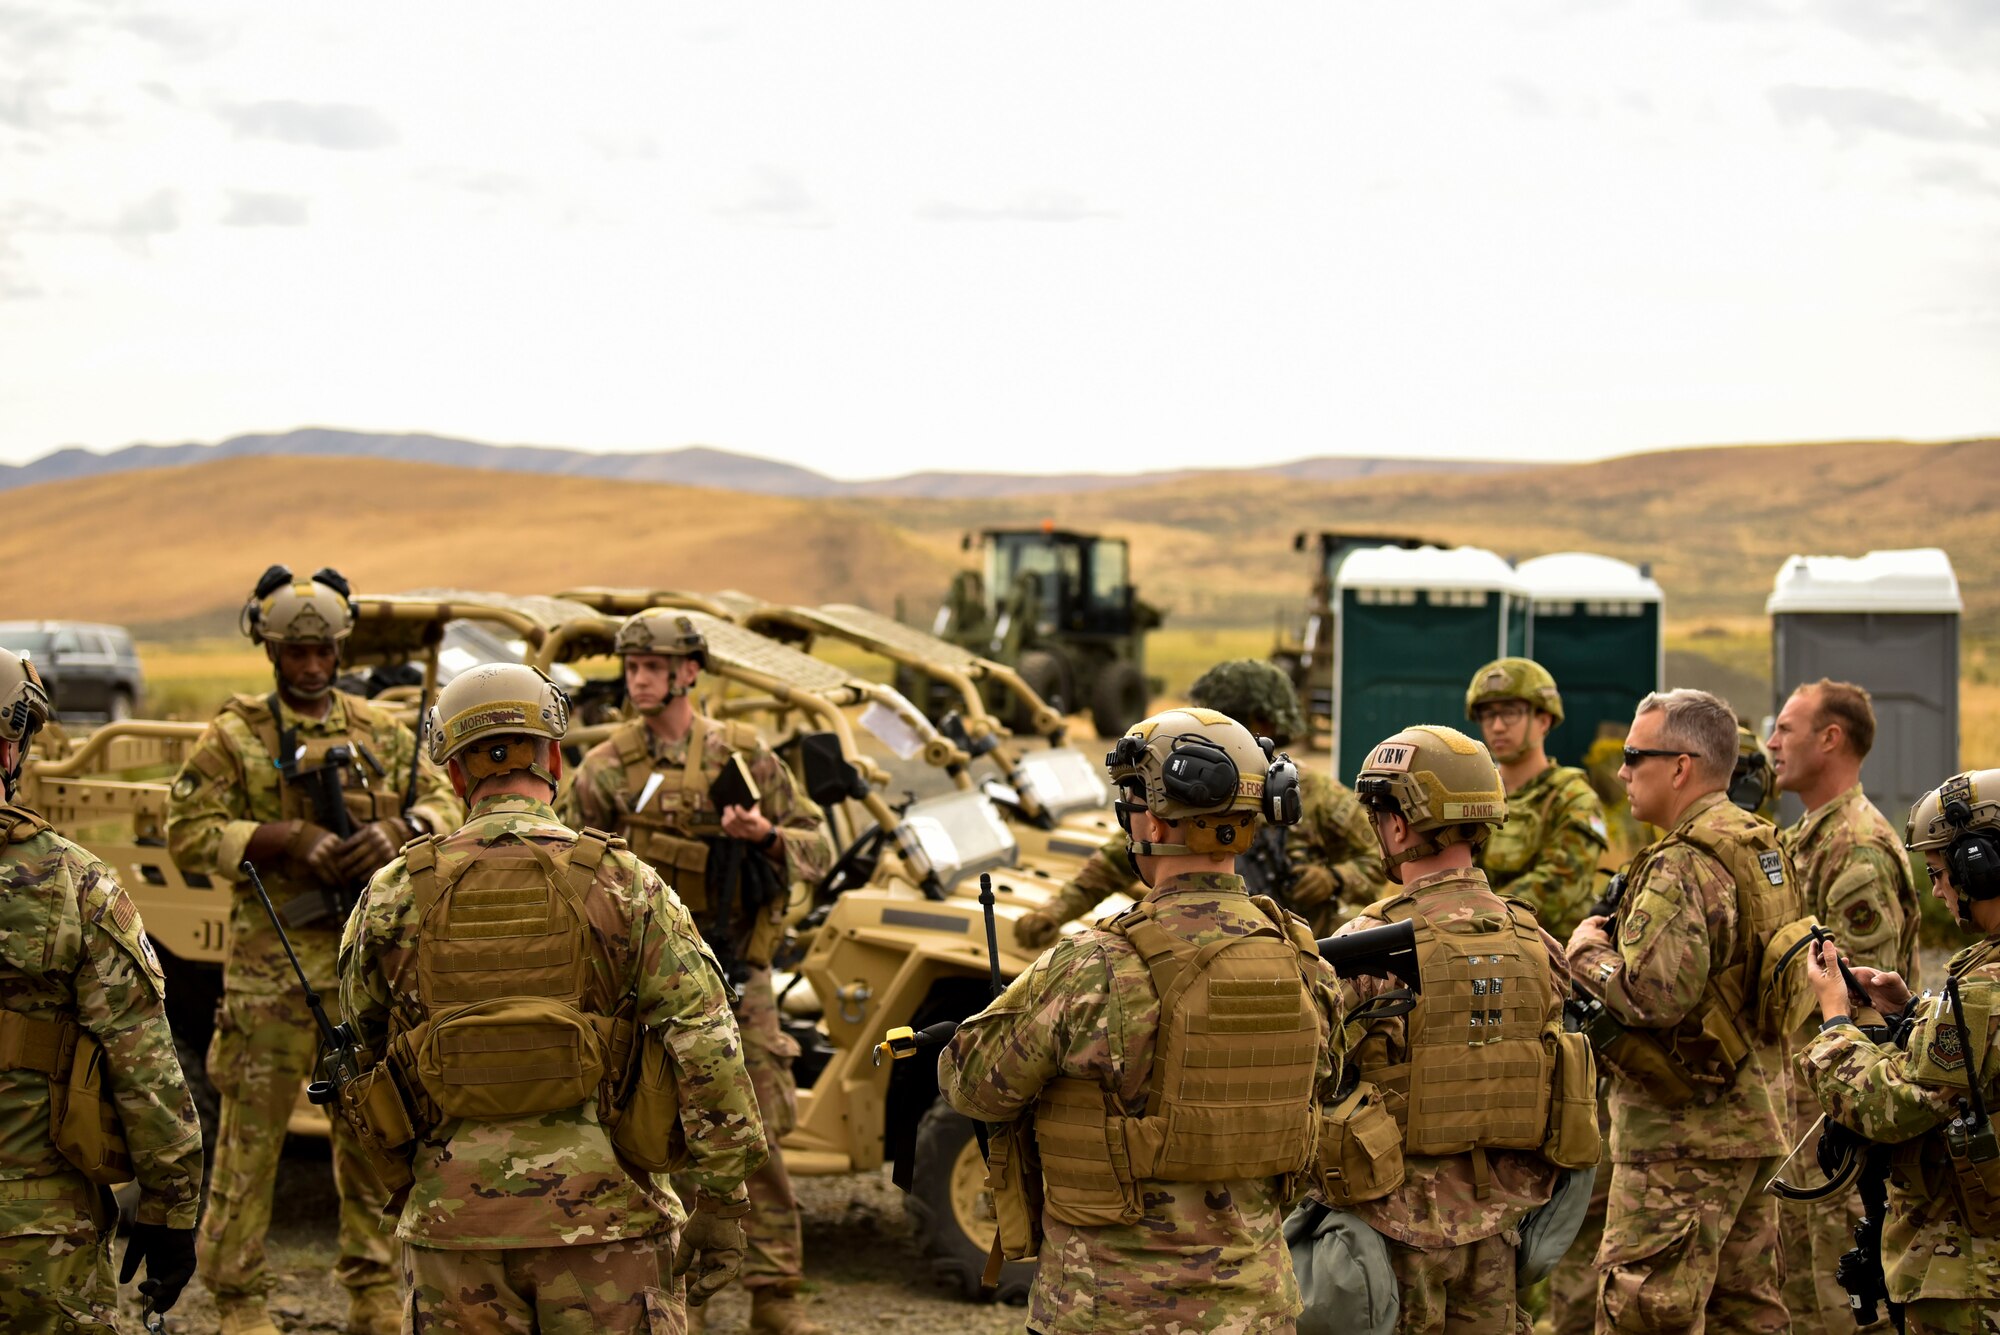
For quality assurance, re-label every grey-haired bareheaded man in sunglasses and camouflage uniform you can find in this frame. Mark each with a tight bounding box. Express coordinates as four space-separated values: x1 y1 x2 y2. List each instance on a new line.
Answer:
1568 689 1804 1333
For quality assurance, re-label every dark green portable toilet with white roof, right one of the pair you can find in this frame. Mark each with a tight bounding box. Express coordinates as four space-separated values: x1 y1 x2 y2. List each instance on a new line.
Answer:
1514 552 1666 765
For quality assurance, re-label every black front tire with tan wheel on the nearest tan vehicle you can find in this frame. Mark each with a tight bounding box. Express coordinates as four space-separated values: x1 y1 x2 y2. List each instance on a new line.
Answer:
902 1099 1034 1303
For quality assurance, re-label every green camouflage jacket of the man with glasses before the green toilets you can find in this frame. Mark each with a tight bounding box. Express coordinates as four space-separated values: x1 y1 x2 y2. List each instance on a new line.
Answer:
1480 765 1608 941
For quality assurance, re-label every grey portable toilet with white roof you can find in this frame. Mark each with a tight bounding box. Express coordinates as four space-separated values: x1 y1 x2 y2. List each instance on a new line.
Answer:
1764 548 1964 829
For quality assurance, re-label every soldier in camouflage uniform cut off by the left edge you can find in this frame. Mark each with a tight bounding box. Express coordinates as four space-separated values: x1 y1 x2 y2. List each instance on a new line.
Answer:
0 650 202 1335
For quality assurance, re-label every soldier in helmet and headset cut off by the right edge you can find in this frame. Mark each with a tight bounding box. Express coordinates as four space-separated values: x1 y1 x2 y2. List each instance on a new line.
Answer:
1788 759 2000 1335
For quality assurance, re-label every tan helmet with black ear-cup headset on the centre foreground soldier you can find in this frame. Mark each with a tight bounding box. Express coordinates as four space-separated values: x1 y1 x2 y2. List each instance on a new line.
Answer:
1104 709 1300 857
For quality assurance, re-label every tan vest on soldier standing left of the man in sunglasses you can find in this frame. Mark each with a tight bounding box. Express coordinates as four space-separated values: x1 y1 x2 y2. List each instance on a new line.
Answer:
1362 895 1562 1155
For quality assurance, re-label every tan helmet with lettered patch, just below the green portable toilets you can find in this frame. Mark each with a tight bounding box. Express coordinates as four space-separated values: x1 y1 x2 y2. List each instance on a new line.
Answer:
1354 723 1504 885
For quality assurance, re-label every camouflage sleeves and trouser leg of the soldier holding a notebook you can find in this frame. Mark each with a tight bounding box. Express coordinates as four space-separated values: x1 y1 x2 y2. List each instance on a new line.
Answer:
560 715 834 1293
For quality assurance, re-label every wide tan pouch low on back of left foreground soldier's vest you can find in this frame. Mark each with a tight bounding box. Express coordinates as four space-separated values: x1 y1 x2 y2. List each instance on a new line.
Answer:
412 997 604 1119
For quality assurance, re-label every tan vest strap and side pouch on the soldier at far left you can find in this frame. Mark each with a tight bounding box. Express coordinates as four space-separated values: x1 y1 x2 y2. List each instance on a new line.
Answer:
0 805 132 1187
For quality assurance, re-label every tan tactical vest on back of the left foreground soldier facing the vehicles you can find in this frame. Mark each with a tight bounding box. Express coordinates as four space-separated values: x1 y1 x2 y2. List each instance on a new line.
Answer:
372 829 632 1123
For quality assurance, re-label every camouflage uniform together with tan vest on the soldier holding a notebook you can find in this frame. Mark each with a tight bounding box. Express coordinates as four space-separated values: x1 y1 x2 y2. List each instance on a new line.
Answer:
562 713 834 1293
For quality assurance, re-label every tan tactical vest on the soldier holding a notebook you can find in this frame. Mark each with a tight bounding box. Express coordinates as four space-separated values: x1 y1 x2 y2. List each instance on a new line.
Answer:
610 713 758 917
